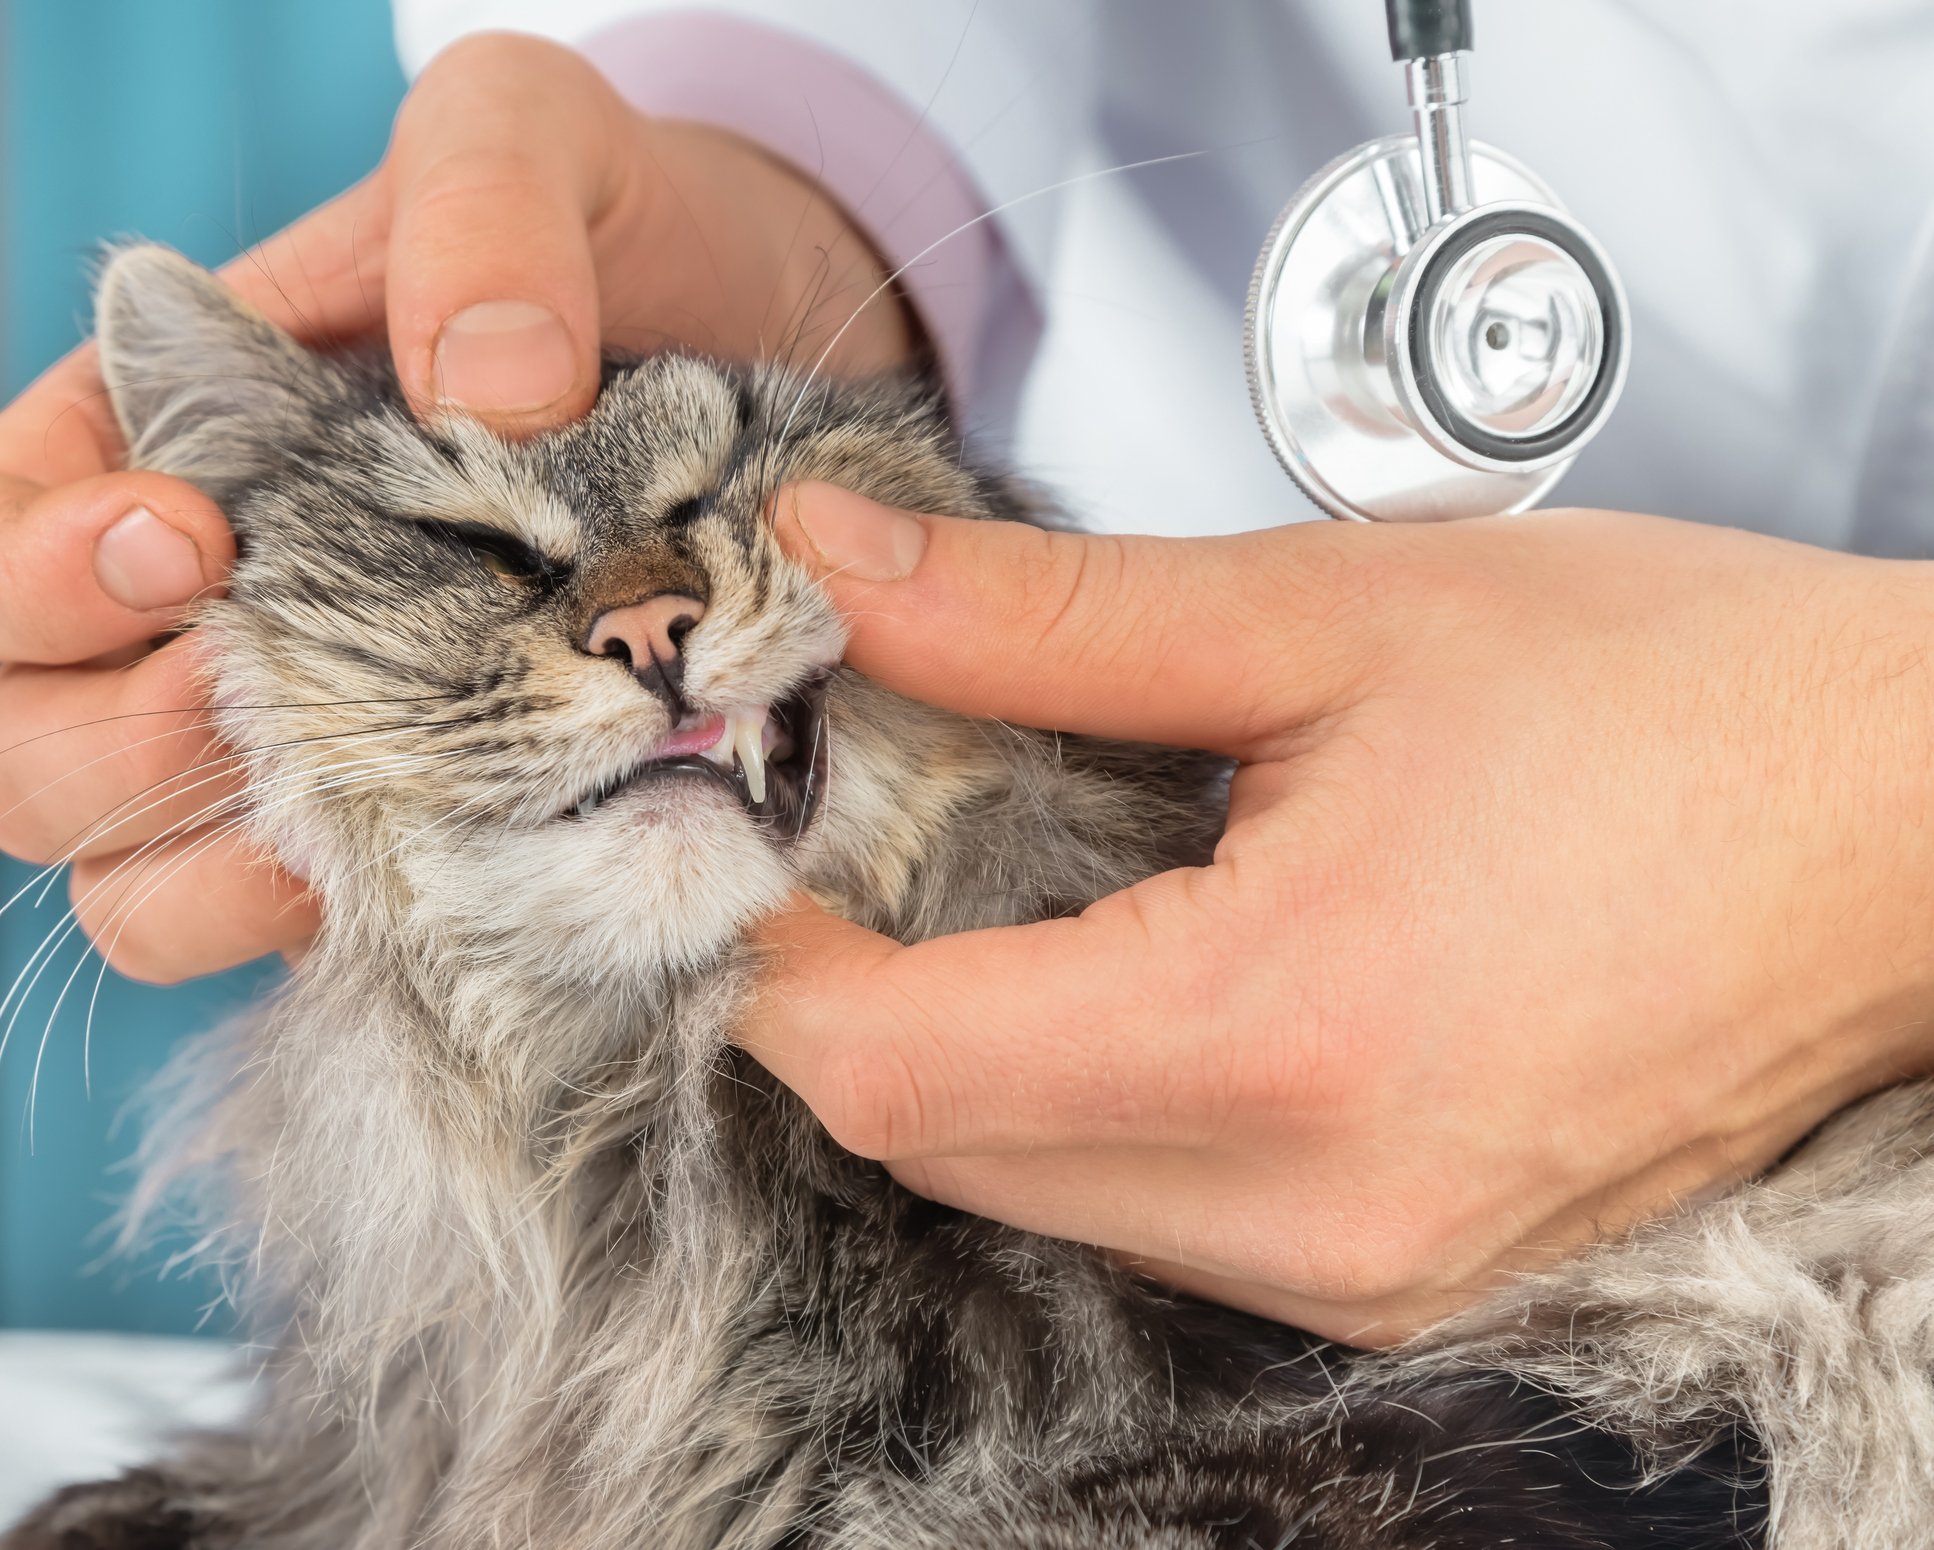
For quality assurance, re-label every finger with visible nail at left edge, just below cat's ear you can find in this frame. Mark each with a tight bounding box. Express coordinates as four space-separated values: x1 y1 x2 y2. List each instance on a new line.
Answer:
0 472 234 662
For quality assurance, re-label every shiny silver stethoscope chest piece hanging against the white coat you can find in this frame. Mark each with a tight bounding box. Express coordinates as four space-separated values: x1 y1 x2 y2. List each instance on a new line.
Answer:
1247 0 1630 522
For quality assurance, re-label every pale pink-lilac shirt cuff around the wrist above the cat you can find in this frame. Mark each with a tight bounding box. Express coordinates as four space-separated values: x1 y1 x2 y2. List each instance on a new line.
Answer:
582 12 1025 410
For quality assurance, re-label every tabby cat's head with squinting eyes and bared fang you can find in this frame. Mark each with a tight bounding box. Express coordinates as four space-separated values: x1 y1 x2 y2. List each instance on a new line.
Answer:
97 246 1214 1006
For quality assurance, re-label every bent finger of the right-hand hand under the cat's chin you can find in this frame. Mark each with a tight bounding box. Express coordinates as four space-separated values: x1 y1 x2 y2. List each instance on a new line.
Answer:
737 871 1238 1159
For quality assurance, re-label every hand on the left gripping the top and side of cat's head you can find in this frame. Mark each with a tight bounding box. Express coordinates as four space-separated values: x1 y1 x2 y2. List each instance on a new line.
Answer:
0 35 913 981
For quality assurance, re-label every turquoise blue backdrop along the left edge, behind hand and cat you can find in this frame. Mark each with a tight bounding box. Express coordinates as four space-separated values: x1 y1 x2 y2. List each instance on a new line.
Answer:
0 0 402 1331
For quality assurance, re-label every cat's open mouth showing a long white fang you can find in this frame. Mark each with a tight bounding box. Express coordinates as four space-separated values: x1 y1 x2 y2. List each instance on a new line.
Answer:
561 673 832 840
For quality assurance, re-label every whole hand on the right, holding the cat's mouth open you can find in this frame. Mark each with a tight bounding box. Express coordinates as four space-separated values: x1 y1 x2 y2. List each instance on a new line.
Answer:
741 486 1934 1345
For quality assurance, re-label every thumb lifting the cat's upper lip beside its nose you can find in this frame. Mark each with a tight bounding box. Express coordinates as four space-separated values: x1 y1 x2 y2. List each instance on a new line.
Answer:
774 484 1391 757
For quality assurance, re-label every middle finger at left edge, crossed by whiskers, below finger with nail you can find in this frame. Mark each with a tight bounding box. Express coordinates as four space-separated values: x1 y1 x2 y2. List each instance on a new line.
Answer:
0 641 242 865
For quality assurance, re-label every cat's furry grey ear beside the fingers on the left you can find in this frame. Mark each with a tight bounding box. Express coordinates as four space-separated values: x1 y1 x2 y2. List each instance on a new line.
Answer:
95 242 331 484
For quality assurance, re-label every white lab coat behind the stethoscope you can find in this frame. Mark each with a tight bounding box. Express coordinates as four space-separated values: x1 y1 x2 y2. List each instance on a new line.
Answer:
396 0 1934 553
